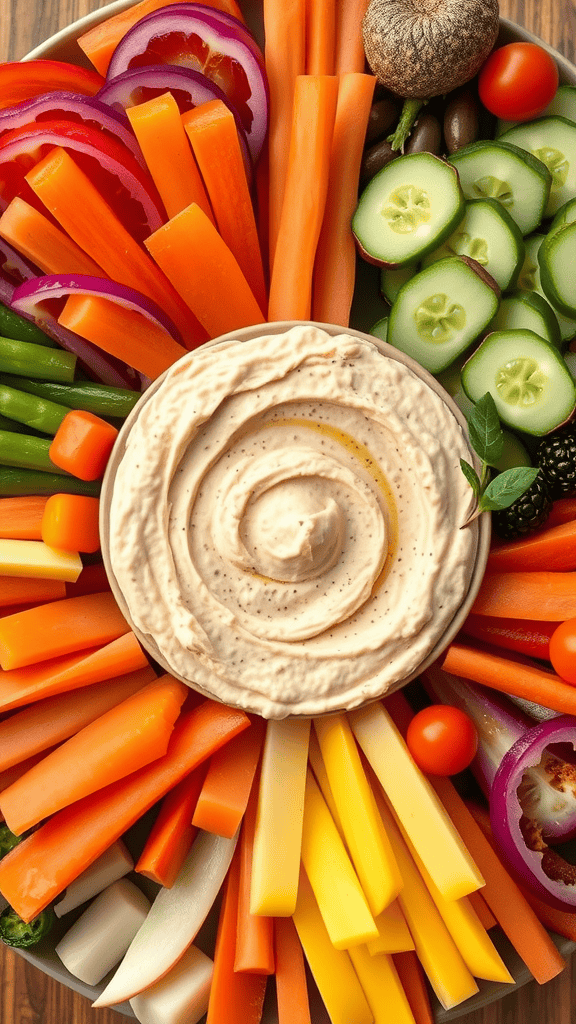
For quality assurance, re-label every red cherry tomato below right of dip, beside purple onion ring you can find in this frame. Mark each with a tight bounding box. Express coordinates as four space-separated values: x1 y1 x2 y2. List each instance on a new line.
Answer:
406 705 478 775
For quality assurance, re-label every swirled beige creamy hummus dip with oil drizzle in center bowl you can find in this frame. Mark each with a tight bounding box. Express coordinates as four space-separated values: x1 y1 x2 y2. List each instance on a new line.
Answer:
109 327 477 718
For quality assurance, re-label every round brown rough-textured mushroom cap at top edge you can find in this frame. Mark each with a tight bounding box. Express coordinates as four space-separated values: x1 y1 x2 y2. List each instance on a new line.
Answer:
363 0 499 99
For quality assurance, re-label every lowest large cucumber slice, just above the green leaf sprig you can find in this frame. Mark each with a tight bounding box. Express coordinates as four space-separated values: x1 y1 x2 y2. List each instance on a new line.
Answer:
462 331 576 437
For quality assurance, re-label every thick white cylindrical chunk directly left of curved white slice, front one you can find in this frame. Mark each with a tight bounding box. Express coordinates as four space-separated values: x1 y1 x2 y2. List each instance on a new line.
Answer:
56 879 150 985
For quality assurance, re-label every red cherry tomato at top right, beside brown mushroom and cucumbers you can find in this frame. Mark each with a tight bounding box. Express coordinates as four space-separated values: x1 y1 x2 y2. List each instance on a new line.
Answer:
478 43 559 121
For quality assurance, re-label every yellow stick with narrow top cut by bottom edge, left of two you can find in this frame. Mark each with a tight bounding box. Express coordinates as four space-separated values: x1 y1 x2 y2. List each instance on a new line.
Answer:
294 869 374 1024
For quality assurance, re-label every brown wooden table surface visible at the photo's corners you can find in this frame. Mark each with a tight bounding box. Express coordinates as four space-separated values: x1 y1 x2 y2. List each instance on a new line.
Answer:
0 0 576 1024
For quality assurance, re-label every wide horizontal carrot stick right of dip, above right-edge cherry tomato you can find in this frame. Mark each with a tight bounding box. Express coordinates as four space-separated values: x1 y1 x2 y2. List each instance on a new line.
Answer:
471 571 576 623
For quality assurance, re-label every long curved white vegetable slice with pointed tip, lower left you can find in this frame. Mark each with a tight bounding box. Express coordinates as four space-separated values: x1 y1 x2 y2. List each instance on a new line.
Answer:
92 831 238 1007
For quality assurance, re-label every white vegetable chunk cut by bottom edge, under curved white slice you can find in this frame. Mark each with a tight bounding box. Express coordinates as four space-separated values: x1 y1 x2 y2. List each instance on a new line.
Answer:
130 946 214 1024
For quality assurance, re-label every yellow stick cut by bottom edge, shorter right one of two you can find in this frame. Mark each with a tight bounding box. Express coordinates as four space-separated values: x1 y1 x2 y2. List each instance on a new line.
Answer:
349 946 416 1024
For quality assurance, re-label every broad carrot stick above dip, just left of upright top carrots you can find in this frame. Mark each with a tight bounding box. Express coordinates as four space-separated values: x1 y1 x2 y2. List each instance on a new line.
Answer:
146 203 264 338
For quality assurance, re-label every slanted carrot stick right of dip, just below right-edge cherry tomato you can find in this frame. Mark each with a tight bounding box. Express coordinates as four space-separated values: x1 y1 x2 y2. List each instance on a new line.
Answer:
439 643 576 715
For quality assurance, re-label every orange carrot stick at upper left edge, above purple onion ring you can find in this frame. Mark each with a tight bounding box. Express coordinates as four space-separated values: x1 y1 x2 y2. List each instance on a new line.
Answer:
0 197 106 278
